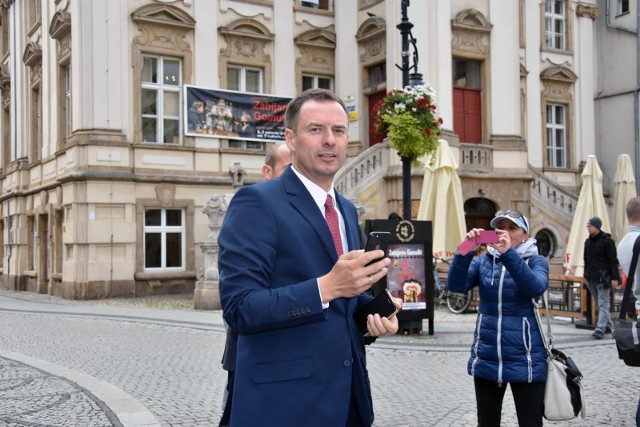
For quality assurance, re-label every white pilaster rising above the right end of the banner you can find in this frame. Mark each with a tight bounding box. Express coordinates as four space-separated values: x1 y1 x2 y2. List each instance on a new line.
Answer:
274 1 296 96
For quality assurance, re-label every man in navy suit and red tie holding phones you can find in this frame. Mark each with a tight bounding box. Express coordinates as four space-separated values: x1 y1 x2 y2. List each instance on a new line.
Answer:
218 89 401 427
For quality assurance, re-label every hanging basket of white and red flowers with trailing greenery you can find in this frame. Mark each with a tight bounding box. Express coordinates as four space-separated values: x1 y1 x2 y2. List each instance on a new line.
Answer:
373 85 442 161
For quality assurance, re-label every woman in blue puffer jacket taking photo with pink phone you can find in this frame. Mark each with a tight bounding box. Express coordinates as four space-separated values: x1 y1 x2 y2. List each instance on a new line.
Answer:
447 210 549 427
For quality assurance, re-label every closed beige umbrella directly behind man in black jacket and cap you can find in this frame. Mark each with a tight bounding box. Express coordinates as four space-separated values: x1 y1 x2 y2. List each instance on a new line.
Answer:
564 155 611 276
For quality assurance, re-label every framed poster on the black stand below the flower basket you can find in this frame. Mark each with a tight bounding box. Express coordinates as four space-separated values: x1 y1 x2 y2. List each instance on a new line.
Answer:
387 244 427 310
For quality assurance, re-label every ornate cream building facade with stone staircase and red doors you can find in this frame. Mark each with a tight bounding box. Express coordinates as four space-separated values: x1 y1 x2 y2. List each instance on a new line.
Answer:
0 0 620 299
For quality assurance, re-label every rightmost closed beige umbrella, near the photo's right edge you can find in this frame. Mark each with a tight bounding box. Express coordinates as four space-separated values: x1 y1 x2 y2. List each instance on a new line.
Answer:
611 154 637 242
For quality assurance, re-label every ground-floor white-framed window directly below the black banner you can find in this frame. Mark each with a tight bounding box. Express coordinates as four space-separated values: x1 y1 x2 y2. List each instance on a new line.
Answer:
144 208 186 271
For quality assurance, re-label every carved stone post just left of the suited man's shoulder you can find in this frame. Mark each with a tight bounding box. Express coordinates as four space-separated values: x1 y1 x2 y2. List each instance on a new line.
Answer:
193 194 227 310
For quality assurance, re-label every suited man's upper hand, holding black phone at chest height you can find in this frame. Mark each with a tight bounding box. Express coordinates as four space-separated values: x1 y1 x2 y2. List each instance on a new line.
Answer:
319 249 391 303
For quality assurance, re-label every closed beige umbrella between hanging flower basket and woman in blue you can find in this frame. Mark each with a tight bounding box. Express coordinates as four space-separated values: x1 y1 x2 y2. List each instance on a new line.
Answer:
417 139 467 258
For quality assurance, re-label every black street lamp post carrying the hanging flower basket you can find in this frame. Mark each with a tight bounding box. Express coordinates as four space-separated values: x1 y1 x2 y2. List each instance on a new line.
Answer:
396 0 424 220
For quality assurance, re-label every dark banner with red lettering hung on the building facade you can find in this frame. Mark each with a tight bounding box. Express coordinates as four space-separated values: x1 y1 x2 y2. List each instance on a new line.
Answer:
184 85 291 141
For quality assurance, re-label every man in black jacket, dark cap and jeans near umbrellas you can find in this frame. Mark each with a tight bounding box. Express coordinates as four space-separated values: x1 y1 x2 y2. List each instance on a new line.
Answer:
584 216 620 339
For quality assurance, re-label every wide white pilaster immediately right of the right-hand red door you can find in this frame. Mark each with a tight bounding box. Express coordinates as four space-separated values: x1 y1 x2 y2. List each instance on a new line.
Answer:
489 0 520 135
